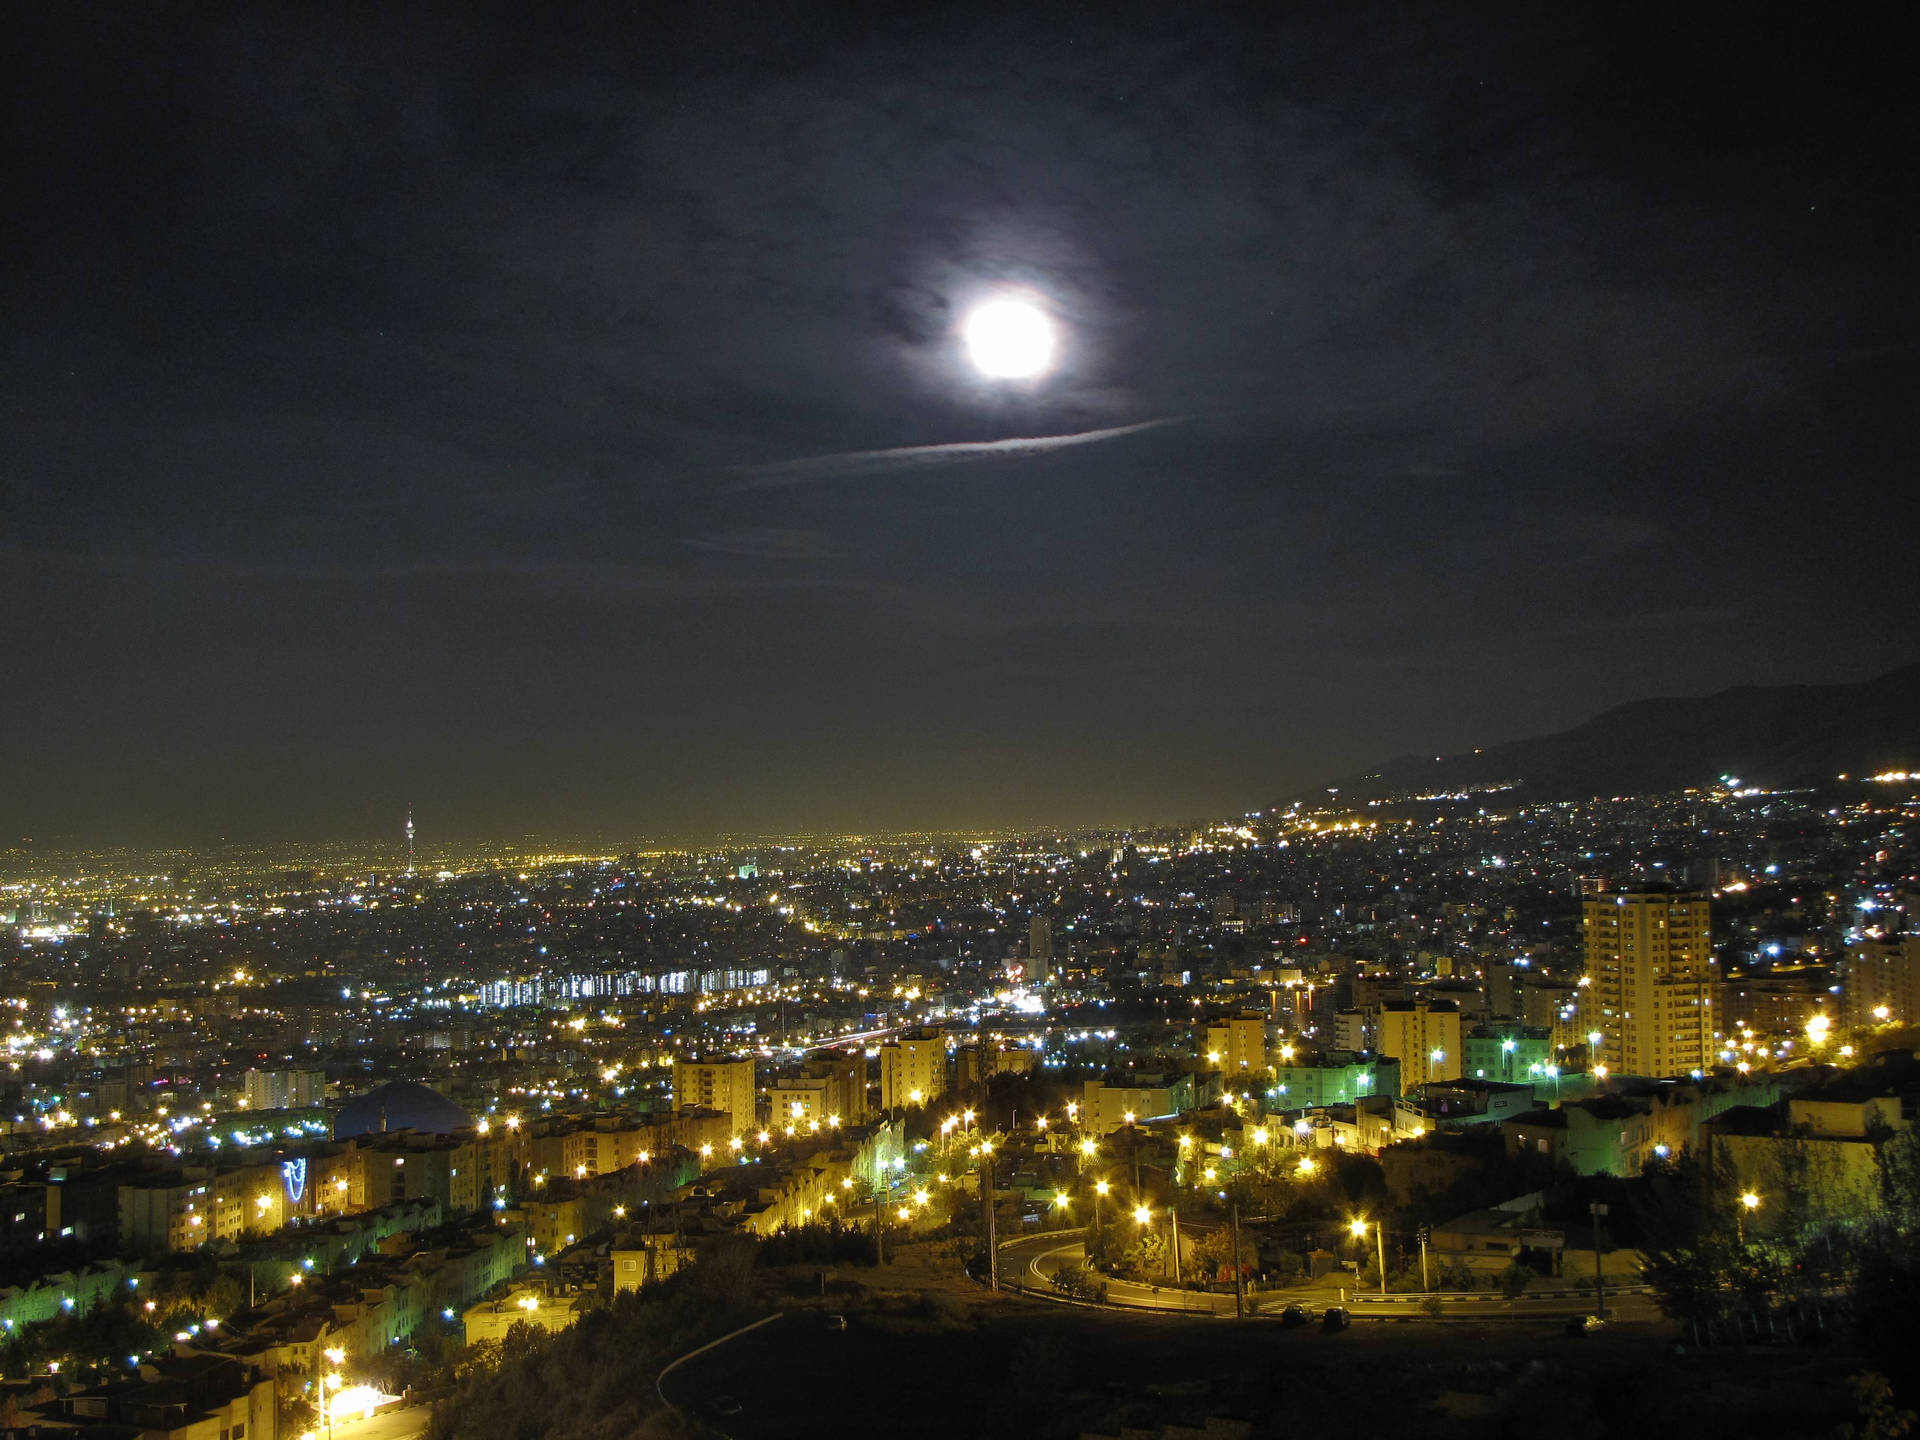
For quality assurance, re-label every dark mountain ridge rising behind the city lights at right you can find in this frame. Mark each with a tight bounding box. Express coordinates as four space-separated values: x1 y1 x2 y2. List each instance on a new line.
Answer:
1304 664 1920 801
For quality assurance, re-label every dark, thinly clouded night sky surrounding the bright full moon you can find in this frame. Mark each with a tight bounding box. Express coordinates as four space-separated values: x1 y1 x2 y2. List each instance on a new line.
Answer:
0 0 1920 843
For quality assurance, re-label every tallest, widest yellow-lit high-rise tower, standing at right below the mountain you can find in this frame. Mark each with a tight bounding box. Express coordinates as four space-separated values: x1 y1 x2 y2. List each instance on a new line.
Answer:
1580 889 1713 1079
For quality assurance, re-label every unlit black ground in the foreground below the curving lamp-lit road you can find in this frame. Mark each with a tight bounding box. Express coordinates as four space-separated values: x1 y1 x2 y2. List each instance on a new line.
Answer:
668 1292 1864 1440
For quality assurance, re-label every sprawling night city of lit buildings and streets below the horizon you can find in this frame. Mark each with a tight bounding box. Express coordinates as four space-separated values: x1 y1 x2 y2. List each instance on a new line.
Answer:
0 774 1920 1440
